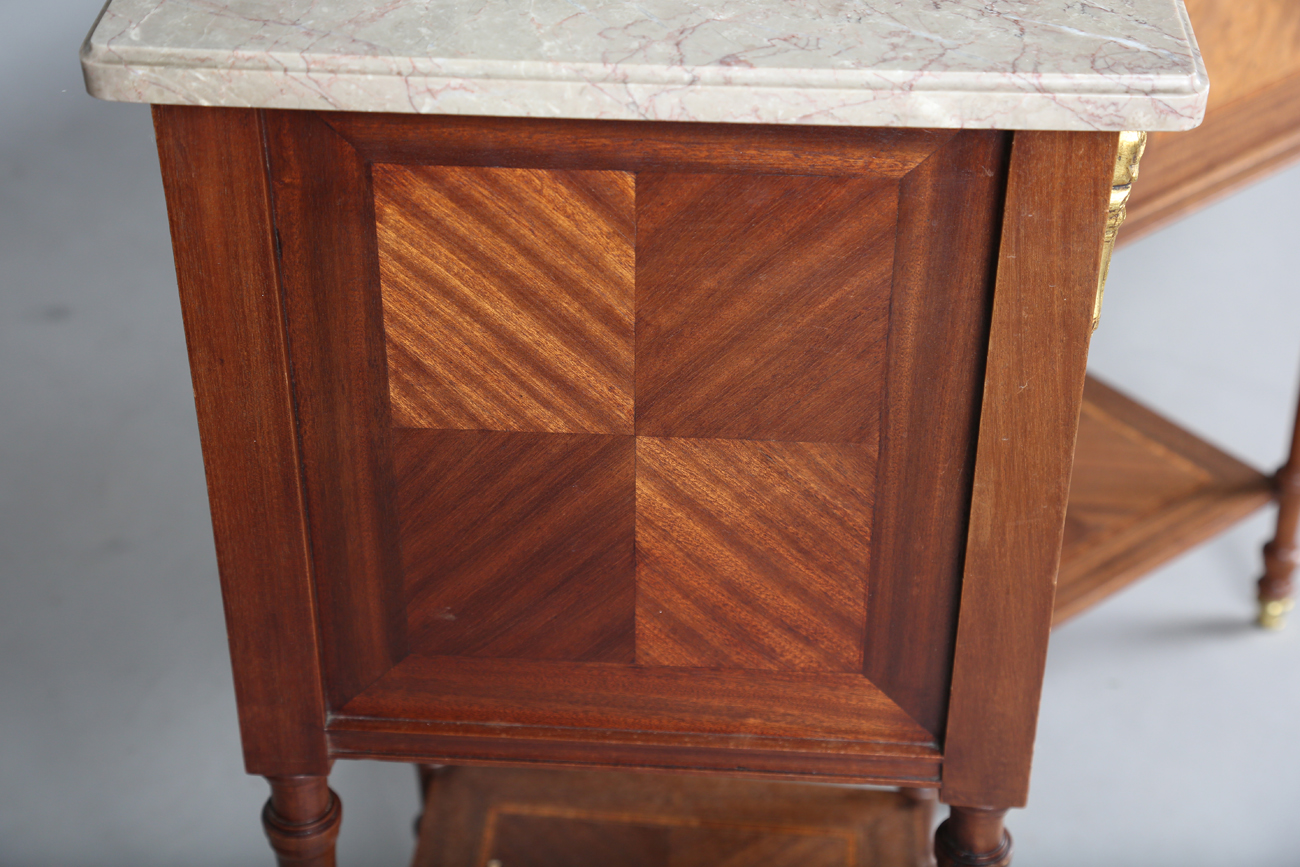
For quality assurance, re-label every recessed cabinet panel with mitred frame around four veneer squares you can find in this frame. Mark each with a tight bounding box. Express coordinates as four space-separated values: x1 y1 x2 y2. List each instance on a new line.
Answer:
265 112 1009 781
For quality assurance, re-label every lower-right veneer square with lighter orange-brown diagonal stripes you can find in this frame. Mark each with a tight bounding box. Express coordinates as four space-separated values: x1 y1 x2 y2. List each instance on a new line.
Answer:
637 437 876 672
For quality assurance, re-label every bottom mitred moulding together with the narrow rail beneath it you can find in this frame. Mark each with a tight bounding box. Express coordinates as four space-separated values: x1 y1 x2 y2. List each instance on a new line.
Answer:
332 644 939 784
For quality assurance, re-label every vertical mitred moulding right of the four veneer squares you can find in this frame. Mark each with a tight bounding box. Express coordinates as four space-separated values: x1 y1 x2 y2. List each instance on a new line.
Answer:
863 130 1010 738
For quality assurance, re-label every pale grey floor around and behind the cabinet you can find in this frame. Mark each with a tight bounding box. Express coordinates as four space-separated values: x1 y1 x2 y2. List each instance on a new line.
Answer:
0 0 1300 867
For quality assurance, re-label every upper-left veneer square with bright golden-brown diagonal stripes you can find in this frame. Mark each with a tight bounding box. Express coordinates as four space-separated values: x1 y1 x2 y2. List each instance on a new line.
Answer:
374 165 634 433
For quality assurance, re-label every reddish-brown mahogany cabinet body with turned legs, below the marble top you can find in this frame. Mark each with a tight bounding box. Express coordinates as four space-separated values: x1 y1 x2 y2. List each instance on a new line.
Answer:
155 107 1118 864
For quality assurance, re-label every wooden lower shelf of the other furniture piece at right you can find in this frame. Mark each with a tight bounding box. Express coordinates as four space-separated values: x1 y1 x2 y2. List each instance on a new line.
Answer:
1053 377 1271 625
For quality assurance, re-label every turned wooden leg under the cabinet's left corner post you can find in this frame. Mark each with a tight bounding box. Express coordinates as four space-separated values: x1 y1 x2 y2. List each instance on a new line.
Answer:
261 776 343 867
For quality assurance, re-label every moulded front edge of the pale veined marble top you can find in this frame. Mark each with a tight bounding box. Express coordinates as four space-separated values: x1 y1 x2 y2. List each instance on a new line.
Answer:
82 0 1209 130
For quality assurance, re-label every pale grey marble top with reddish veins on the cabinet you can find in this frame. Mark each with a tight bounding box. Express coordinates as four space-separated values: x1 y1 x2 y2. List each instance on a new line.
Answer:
82 0 1209 130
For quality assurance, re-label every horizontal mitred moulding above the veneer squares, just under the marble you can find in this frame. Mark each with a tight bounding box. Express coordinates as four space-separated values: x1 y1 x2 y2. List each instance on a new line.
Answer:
320 113 956 177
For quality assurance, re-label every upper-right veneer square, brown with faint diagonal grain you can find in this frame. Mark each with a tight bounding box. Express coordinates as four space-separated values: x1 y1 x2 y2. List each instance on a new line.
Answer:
636 173 898 442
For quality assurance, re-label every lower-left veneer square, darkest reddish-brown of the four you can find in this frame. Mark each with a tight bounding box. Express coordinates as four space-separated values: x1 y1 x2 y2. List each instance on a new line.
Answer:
394 430 636 663
